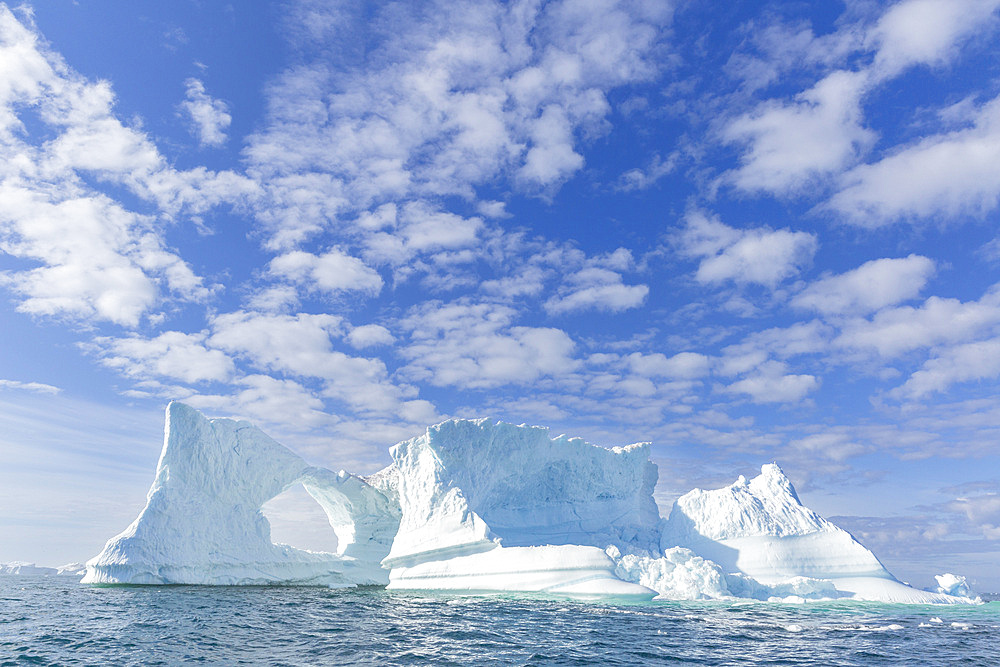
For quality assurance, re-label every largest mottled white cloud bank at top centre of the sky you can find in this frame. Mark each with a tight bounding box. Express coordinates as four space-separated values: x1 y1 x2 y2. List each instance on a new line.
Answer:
247 0 670 249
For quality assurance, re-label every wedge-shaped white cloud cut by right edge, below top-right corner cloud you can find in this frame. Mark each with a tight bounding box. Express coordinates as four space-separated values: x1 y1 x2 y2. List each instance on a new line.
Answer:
826 97 1000 227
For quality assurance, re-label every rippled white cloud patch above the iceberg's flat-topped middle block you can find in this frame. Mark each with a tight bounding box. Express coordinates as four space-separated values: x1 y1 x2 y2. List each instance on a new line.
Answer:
399 300 578 389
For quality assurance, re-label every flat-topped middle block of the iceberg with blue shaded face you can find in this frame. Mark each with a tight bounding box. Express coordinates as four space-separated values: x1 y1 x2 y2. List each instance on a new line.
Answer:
368 419 660 599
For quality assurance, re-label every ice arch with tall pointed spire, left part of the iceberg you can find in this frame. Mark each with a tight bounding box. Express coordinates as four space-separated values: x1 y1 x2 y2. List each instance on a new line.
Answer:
83 402 399 586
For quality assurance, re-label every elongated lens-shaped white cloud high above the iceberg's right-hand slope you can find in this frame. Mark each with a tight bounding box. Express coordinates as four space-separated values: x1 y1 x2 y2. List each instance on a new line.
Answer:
792 255 934 315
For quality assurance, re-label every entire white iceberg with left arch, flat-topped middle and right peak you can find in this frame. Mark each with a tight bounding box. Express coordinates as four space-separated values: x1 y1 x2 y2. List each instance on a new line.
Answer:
83 403 972 603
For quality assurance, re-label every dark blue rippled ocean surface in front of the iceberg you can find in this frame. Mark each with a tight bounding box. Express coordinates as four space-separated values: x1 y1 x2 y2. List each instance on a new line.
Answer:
0 576 1000 666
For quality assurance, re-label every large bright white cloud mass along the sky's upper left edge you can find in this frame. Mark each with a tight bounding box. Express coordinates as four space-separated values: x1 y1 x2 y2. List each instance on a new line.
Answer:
0 6 254 327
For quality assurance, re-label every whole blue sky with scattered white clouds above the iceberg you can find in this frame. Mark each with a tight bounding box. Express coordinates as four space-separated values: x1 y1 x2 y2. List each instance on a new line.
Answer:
0 0 1000 591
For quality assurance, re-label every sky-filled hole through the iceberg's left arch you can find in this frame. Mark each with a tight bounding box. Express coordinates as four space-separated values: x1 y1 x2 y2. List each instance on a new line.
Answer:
260 484 337 554
